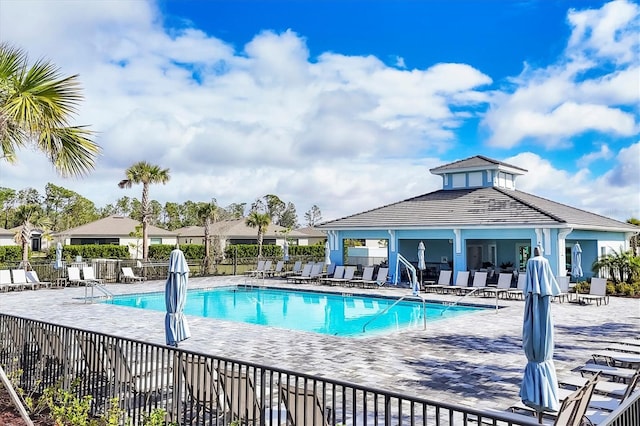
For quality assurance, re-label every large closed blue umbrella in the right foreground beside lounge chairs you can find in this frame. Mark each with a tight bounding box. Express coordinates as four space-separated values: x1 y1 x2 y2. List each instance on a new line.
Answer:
520 247 560 420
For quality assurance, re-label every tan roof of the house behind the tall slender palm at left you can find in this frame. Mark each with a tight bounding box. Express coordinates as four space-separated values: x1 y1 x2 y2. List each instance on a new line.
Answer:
55 216 176 237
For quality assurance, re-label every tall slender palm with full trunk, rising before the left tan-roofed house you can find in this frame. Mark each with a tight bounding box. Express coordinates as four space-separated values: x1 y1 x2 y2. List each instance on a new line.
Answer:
118 161 169 261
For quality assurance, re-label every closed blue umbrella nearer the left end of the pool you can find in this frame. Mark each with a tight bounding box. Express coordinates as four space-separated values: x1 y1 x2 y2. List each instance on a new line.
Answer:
164 248 191 347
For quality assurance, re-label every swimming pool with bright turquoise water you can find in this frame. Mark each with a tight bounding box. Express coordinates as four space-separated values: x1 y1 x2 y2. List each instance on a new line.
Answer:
105 286 486 337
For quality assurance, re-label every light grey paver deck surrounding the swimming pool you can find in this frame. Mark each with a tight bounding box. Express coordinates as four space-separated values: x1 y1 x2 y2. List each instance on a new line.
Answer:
0 276 640 409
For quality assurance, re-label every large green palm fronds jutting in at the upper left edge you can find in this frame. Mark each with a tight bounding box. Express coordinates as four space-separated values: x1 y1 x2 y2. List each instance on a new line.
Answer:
0 43 100 176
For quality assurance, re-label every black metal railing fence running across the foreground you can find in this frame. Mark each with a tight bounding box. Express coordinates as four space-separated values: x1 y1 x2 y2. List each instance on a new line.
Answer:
0 314 638 426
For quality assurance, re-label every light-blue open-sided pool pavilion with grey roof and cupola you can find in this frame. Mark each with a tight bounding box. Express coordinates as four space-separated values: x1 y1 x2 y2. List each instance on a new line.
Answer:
318 156 640 280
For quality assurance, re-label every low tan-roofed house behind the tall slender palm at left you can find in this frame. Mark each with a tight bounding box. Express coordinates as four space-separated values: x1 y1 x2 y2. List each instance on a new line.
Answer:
53 216 177 259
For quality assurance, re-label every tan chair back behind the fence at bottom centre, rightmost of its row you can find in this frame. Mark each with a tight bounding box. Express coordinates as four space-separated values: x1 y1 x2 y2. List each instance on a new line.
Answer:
280 384 332 426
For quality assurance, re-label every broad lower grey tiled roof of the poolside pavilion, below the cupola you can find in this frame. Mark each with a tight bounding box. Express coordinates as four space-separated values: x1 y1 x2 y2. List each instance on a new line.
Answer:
318 187 640 232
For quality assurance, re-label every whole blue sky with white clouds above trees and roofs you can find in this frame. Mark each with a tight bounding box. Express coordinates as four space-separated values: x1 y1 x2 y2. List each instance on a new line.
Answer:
0 0 640 220
